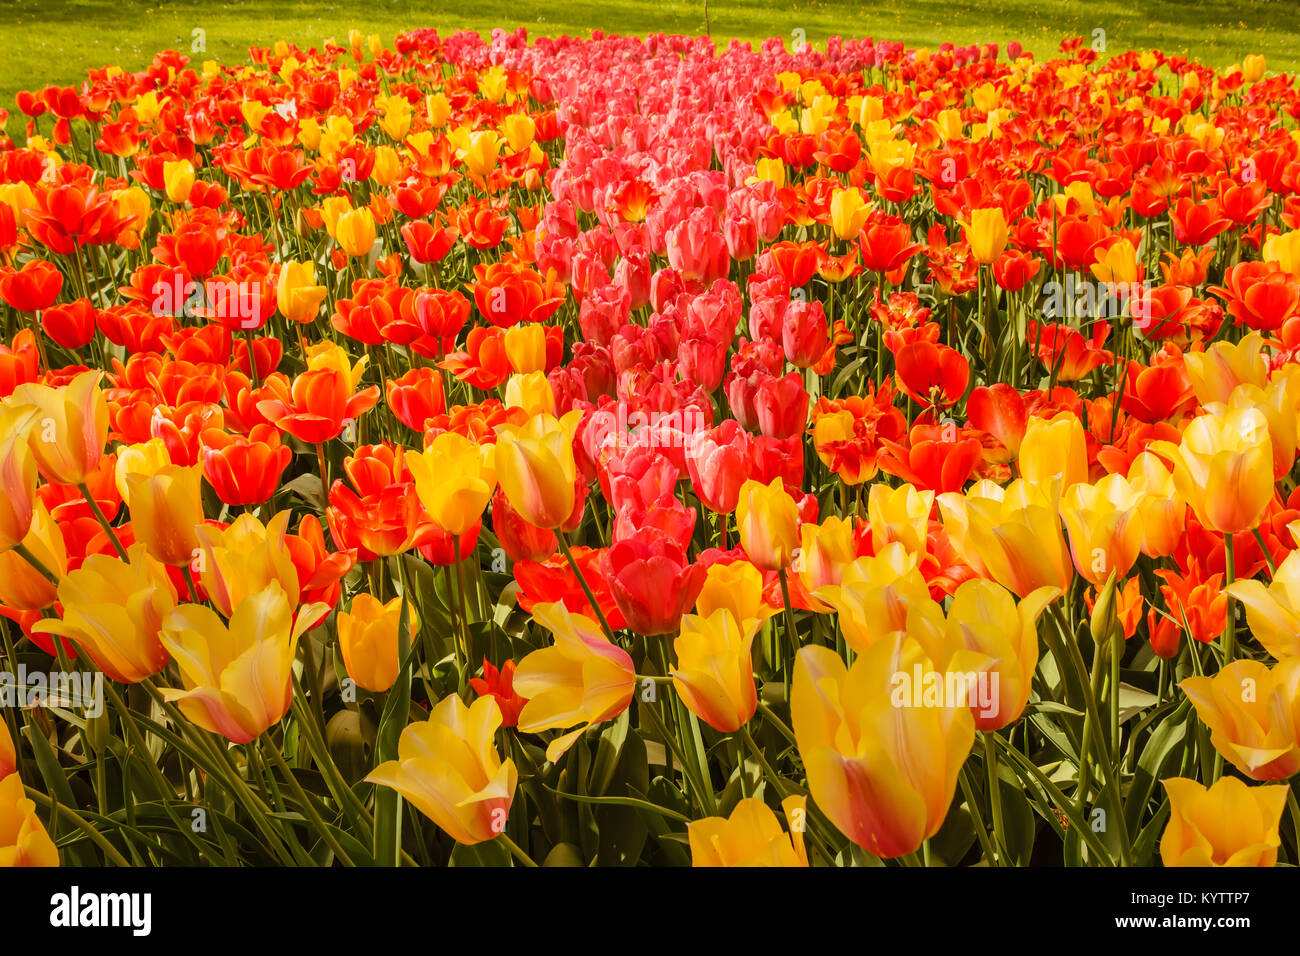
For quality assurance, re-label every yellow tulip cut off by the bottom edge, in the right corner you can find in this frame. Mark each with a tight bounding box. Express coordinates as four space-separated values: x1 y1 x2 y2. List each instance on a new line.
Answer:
1160 777 1287 866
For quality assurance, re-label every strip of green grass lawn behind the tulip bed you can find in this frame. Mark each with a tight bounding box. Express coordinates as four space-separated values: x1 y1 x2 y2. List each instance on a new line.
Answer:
0 0 1300 139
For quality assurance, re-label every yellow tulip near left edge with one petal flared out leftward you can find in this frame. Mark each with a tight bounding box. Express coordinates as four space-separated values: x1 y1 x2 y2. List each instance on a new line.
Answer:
33 544 177 684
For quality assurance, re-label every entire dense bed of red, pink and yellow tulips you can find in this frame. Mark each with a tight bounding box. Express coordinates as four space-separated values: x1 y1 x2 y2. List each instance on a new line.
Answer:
0 30 1300 866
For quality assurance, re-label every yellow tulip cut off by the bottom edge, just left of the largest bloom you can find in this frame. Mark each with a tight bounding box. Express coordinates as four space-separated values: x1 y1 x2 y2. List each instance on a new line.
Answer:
686 796 809 866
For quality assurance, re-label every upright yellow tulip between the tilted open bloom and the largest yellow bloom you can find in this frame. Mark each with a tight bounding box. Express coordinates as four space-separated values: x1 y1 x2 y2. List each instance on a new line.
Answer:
672 609 759 734
